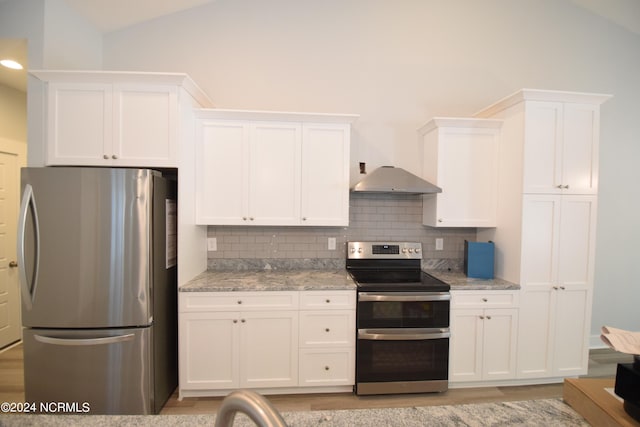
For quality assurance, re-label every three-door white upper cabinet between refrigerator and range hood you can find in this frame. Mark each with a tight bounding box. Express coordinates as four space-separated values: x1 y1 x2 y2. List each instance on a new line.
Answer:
196 110 354 226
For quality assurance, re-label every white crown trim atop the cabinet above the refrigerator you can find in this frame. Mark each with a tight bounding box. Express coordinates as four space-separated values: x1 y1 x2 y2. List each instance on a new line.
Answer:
29 70 213 108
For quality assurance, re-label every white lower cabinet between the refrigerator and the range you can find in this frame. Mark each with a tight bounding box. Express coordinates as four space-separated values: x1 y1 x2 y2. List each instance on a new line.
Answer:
179 291 355 398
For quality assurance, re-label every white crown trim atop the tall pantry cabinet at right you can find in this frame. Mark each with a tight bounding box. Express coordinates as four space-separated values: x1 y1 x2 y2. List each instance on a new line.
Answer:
474 89 613 118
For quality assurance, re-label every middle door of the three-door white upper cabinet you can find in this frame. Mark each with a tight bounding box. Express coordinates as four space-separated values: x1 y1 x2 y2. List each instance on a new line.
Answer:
249 122 302 225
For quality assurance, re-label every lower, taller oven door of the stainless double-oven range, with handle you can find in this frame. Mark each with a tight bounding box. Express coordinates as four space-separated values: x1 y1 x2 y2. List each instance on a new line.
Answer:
356 328 450 395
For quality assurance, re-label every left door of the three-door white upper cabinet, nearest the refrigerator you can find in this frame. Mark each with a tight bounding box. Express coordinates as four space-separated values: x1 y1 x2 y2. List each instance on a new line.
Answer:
196 120 249 225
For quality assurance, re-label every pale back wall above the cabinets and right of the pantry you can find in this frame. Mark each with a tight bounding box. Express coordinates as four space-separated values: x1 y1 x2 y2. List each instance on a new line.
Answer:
103 0 640 342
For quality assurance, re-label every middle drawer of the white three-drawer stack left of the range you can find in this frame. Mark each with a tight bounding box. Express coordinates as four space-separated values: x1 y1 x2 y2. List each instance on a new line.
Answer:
300 310 356 347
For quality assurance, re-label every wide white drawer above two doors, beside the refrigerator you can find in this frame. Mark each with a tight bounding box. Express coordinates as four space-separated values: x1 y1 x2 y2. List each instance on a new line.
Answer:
180 292 298 312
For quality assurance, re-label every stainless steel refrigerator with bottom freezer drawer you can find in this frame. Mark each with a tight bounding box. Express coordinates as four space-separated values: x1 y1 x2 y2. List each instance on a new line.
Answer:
18 167 178 414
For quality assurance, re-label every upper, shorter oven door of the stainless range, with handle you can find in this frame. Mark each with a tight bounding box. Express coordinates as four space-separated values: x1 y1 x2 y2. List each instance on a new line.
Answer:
357 292 451 329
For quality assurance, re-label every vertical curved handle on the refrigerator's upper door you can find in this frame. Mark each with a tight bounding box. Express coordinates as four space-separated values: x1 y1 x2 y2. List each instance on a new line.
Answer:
18 184 40 310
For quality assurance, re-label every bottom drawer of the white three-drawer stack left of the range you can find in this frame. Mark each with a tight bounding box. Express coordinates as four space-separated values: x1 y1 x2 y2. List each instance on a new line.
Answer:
299 348 355 387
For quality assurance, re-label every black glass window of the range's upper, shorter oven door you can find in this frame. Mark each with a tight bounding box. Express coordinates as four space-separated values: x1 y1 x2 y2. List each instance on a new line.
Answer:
358 301 449 329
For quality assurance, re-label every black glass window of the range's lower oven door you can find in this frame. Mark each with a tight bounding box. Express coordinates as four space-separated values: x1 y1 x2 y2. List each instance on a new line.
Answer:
356 338 449 382
